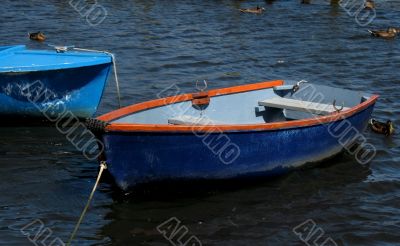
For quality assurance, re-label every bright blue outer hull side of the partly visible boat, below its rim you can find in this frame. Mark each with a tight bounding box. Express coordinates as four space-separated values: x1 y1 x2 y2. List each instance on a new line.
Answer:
0 63 111 119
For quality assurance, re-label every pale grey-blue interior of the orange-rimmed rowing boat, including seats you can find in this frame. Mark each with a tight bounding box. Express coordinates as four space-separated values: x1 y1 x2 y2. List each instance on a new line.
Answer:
112 83 371 125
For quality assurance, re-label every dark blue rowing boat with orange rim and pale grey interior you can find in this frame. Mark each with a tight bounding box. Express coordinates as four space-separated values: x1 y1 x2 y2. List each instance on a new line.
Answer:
88 81 378 189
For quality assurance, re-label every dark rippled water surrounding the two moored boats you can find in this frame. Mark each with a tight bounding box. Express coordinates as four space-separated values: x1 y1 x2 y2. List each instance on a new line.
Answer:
0 0 400 245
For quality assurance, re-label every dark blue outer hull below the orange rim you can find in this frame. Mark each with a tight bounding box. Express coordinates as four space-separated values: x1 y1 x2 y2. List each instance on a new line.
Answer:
102 104 374 189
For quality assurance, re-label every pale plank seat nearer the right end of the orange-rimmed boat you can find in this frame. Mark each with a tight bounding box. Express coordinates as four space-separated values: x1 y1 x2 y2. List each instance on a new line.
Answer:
258 97 349 115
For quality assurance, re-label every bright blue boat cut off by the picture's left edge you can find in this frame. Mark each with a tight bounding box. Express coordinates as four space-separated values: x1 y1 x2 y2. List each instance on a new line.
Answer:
0 45 112 119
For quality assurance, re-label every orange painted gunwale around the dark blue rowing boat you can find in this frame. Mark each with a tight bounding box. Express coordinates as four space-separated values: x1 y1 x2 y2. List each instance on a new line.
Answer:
97 80 379 133
